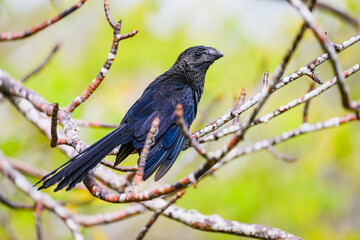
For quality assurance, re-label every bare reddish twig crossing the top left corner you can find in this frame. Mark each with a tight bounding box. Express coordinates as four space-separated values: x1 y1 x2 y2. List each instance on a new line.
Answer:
0 0 86 41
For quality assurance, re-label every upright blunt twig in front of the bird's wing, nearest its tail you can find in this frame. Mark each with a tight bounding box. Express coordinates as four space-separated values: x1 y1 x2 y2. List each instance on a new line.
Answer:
135 117 160 185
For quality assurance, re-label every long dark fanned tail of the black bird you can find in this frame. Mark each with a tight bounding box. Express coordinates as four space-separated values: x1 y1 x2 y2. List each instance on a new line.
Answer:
35 127 128 192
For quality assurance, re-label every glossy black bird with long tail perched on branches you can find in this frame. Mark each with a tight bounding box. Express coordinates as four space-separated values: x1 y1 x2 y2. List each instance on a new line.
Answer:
36 46 223 191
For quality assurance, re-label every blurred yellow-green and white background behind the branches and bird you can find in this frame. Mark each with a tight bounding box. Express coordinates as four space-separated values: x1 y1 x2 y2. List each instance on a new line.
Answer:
0 0 360 240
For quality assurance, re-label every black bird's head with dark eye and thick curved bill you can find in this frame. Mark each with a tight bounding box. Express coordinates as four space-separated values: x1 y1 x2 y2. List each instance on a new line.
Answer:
173 46 223 81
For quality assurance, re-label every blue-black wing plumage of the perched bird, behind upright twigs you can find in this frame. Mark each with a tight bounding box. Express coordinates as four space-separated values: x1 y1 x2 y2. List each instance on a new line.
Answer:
124 75 196 181
